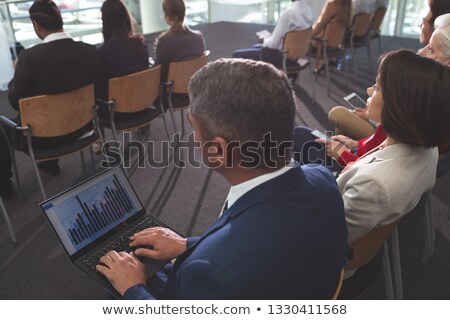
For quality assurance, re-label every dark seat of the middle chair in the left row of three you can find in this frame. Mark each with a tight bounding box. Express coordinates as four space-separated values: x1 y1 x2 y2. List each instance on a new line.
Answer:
100 107 161 131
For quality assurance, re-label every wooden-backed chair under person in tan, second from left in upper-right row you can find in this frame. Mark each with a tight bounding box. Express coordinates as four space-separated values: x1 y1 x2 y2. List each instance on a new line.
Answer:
311 22 348 96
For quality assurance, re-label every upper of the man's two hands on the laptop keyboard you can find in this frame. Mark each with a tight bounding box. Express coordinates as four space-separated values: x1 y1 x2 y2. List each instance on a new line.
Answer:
130 227 186 260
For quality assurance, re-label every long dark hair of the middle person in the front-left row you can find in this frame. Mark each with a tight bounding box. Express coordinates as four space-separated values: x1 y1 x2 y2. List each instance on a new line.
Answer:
101 0 133 42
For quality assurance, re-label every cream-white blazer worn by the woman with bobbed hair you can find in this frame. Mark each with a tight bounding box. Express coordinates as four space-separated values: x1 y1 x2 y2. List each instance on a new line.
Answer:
337 143 438 243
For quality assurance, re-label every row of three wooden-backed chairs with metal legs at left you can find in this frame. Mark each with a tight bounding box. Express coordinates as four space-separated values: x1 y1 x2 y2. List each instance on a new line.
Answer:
0 51 209 199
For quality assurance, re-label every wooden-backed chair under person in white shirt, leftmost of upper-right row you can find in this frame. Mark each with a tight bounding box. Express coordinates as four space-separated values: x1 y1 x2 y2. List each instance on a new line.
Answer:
281 28 316 97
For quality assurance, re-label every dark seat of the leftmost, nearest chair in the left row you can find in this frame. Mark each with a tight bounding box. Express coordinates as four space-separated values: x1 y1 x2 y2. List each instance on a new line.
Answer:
33 131 100 161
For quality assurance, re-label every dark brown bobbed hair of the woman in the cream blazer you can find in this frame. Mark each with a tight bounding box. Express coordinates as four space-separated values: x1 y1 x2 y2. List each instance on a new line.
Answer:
378 49 450 147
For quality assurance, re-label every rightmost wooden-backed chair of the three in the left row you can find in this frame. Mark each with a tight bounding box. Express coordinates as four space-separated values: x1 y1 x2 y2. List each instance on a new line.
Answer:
164 51 209 136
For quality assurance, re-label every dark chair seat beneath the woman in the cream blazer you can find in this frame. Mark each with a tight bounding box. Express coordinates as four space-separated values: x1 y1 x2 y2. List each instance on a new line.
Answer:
338 247 383 300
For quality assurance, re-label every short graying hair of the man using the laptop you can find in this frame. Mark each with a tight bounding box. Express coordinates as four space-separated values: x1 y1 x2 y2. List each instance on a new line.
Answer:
189 59 295 143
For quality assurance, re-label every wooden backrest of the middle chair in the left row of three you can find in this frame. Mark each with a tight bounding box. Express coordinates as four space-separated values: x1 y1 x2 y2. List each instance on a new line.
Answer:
108 66 161 112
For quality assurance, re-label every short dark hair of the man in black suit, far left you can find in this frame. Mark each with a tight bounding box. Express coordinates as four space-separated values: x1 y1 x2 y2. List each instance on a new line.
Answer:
28 0 63 31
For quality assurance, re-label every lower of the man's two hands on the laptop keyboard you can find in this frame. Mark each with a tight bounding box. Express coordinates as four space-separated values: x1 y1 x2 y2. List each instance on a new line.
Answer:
96 251 147 296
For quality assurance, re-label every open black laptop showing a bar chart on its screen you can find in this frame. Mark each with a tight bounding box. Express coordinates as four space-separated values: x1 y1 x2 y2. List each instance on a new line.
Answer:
39 166 176 298
